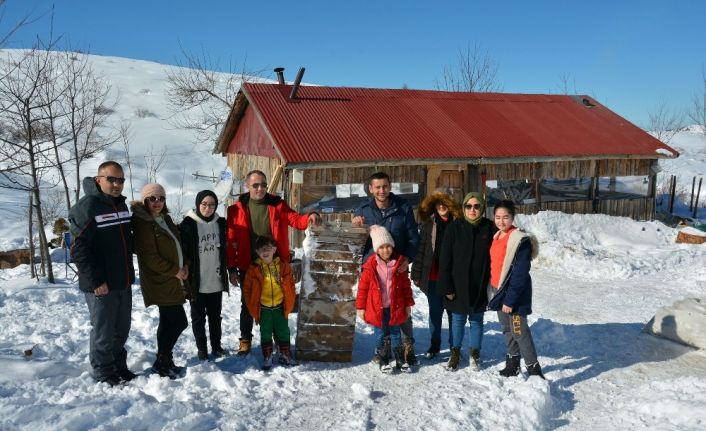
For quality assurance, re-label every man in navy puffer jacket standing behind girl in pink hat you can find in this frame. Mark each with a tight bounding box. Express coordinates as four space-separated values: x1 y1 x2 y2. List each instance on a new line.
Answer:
351 172 419 365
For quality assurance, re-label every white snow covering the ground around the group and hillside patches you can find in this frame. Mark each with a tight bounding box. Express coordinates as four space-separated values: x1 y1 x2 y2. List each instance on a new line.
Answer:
0 51 706 430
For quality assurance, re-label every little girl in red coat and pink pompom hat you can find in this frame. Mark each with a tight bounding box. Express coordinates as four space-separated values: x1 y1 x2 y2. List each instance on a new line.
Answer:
355 225 414 372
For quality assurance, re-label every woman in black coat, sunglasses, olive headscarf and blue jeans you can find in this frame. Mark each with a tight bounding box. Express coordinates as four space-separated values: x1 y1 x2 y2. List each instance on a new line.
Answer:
438 192 497 371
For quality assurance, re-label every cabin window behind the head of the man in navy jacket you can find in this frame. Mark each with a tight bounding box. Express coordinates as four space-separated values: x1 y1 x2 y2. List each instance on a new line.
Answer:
301 183 419 213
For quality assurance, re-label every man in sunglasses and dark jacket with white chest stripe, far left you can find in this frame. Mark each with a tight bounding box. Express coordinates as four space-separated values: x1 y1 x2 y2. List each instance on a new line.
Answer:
69 161 135 386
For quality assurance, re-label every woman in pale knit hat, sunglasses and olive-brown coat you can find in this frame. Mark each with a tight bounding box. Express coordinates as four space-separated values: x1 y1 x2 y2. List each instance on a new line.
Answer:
130 184 190 379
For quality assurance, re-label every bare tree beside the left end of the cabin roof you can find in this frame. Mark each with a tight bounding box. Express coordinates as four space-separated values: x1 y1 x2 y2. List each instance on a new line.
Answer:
167 47 264 142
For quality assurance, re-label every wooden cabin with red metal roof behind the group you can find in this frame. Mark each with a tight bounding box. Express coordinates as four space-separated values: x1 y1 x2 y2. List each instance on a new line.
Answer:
214 83 678 235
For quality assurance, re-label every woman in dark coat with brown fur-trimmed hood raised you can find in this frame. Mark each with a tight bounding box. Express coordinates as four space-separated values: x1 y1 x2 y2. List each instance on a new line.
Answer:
411 189 463 359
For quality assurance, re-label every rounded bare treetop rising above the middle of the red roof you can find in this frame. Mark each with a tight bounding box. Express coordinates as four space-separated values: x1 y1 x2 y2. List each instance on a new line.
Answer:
436 44 500 92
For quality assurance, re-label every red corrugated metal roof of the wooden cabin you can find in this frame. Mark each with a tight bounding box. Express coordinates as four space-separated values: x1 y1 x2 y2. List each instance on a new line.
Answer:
234 83 678 163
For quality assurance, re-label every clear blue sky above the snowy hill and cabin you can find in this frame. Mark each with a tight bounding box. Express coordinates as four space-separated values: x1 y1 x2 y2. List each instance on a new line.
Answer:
0 0 706 126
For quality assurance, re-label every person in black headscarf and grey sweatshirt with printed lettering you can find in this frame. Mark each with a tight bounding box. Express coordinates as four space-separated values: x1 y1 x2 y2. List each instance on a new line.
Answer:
179 190 228 360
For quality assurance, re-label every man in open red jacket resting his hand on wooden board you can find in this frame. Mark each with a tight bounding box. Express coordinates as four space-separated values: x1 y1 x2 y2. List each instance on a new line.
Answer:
226 170 321 356
